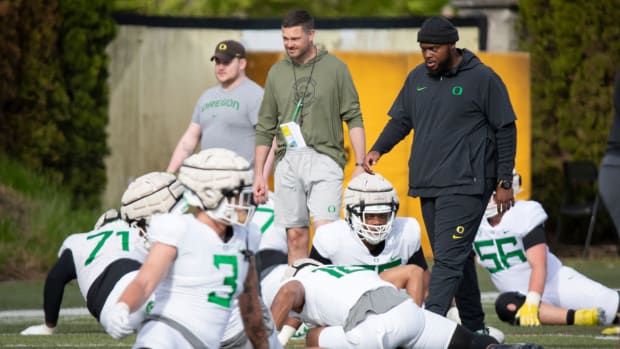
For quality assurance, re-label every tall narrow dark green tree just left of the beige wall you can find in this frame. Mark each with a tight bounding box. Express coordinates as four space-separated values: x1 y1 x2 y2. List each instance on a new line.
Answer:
58 0 116 207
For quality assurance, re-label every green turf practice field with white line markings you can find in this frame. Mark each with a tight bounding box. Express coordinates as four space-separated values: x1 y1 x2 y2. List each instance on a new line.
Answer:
0 257 620 349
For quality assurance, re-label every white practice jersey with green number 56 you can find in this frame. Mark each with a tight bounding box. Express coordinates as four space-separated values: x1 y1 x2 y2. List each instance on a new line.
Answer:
473 200 562 294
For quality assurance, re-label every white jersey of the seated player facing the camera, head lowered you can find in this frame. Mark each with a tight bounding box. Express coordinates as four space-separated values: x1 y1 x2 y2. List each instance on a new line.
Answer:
312 217 421 273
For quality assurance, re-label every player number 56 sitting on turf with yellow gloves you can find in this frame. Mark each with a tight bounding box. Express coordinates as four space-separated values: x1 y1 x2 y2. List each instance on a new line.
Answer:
473 171 620 326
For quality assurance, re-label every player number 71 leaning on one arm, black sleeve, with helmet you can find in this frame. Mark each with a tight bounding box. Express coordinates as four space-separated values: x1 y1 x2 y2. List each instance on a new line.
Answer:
21 172 184 335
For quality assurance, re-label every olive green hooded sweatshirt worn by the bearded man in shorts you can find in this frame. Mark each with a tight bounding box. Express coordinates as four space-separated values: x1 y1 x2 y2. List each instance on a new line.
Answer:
256 49 364 167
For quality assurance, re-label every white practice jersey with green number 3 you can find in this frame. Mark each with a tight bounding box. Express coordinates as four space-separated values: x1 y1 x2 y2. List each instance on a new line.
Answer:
149 214 260 348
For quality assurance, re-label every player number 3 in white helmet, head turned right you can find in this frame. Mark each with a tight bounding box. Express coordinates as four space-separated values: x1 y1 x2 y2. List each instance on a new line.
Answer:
101 148 269 349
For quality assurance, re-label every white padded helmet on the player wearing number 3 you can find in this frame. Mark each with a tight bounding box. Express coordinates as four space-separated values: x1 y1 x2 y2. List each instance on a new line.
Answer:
179 148 256 226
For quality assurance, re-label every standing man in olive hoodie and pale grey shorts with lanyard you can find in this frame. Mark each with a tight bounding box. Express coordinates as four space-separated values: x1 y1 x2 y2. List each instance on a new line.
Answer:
254 10 366 263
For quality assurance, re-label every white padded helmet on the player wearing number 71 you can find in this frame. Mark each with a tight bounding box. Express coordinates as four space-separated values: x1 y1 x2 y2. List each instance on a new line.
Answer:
121 172 187 224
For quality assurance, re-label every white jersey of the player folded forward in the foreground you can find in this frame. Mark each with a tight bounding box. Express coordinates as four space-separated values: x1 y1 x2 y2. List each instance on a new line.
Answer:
292 265 395 326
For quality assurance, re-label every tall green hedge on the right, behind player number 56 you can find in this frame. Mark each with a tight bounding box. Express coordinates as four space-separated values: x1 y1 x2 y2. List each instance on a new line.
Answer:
519 0 620 243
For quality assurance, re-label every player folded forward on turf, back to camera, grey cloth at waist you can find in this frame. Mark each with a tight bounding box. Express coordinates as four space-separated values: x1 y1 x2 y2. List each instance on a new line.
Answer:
271 259 541 349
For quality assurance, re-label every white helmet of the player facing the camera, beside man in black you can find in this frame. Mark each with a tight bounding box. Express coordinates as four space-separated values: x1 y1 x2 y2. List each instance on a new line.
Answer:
344 173 399 245
